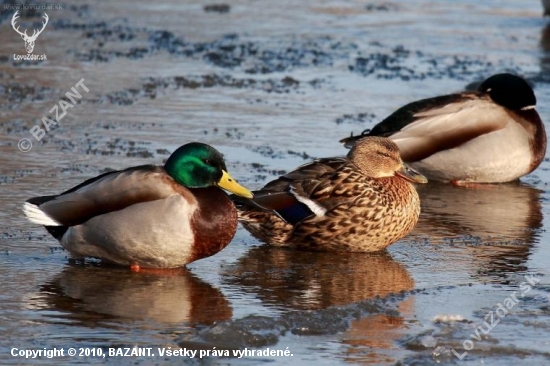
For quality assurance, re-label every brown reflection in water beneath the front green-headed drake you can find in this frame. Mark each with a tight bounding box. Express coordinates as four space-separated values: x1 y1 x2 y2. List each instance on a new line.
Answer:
34 265 232 324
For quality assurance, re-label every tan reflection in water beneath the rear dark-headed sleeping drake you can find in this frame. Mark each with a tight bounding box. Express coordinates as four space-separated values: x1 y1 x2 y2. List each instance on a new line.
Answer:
409 182 543 277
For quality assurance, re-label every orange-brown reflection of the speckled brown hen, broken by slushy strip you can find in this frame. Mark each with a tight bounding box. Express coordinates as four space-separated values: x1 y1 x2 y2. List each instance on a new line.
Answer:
224 246 415 364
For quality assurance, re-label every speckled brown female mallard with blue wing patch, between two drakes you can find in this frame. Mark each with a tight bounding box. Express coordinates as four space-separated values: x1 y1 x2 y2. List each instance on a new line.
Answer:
231 137 426 252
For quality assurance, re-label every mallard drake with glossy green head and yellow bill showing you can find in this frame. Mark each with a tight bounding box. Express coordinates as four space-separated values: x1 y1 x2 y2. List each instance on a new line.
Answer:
23 142 252 270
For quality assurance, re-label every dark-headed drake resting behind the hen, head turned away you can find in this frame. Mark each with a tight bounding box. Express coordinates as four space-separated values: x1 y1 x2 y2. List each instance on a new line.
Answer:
341 74 546 184
